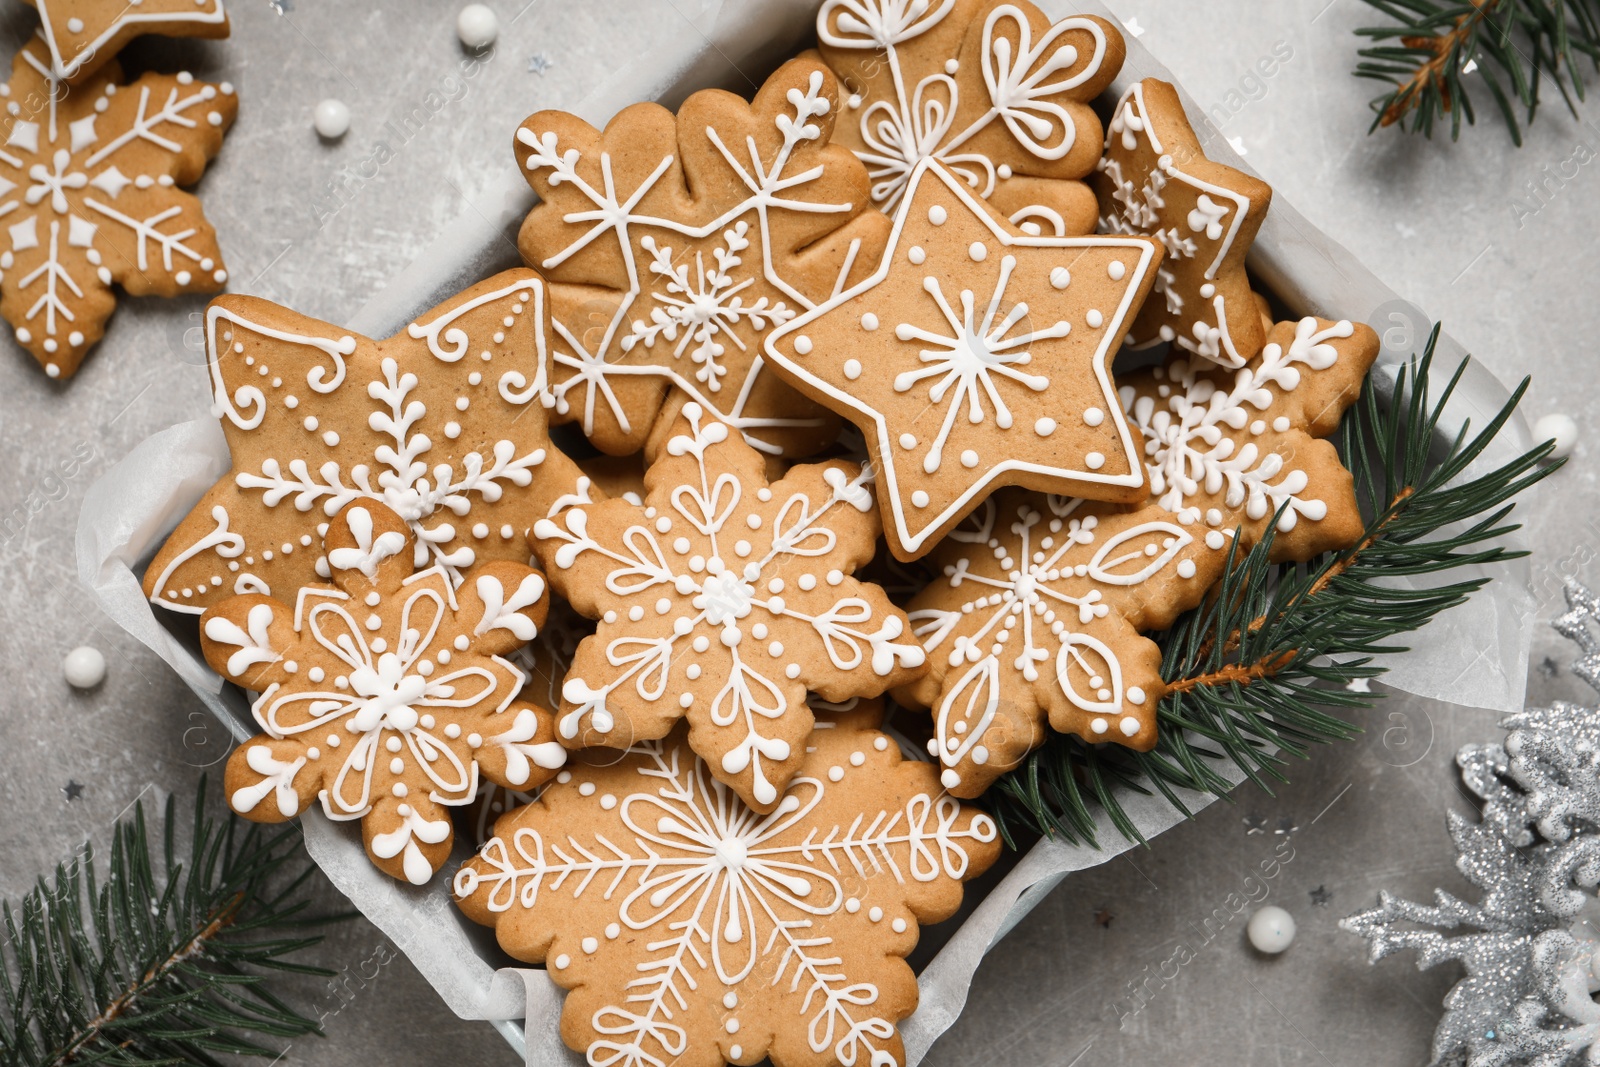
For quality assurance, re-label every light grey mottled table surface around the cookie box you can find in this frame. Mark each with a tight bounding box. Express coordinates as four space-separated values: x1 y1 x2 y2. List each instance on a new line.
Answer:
0 0 1600 1065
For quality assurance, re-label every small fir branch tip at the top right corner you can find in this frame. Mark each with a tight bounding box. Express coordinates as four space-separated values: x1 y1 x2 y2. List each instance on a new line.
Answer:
1355 0 1600 147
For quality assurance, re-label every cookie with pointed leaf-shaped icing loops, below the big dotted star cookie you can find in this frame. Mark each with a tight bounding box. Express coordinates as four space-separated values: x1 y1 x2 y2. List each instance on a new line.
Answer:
898 490 1227 797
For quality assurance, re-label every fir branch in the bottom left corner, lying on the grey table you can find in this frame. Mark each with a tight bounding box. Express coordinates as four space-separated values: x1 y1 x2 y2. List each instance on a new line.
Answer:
0 779 339 1067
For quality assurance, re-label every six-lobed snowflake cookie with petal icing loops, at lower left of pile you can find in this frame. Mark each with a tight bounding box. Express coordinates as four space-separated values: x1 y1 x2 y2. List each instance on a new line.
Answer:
200 502 566 885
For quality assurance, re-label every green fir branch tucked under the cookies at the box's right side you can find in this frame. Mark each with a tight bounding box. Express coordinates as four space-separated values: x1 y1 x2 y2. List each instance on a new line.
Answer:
986 326 1560 846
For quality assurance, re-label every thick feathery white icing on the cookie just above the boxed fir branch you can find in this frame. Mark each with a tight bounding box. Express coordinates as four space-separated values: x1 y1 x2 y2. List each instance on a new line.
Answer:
1120 318 1355 533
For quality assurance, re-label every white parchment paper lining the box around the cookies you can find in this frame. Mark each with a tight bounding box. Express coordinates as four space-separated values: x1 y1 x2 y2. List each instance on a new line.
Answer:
77 0 1533 1064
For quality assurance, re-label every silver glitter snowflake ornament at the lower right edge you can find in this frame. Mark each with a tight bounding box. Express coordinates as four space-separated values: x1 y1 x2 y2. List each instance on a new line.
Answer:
1341 584 1600 1067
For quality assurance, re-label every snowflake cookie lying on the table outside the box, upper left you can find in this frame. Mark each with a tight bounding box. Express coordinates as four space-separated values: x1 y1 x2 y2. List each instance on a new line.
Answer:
0 40 238 378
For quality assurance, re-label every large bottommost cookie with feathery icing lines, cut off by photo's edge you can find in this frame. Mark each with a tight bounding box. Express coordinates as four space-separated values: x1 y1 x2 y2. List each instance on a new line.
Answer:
454 707 1000 1067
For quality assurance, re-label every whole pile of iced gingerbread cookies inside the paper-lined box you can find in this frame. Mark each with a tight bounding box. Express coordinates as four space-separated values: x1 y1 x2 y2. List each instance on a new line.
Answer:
144 0 1378 1065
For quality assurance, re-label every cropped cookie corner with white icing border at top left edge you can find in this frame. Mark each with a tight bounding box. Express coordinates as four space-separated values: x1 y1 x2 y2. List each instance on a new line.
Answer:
26 0 227 85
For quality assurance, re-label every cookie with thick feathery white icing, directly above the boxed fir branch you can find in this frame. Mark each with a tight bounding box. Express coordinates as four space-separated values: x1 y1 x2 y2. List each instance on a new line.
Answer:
1120 318 1378 561
